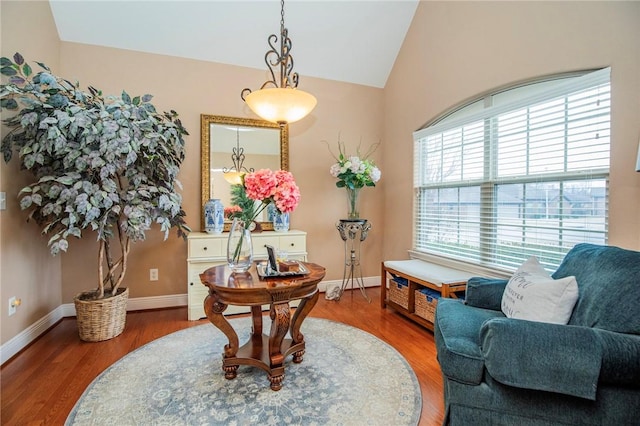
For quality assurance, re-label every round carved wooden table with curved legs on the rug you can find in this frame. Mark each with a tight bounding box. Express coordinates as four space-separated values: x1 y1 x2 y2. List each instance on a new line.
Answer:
200 263 325 391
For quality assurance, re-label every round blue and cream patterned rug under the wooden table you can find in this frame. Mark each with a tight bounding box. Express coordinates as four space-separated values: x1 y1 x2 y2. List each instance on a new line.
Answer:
66 317 422 426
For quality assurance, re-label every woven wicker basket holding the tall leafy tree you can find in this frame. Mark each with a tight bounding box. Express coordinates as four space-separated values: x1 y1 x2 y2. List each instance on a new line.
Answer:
73 288 129 342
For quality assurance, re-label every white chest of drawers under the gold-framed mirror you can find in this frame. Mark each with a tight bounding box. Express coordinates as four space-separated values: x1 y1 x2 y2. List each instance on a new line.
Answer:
187 230 307 320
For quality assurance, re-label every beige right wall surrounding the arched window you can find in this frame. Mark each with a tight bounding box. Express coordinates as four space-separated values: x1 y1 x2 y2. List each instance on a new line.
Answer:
383 2 640 258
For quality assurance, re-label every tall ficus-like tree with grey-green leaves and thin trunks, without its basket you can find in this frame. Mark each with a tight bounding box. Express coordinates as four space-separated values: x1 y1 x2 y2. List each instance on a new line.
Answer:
0 53 189 298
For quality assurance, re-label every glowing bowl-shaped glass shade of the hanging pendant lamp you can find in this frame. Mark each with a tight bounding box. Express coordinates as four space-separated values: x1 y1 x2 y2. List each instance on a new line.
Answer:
245 87 318 124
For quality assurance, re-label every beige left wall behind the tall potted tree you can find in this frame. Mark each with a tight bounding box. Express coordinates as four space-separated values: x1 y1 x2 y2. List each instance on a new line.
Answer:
0 0 61 344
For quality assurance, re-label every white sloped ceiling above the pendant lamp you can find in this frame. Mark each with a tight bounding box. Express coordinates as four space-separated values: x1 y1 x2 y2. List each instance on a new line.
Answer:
49 0 418 87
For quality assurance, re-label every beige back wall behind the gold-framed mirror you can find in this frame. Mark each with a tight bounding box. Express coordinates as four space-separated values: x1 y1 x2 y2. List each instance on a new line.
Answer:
59 42 384 303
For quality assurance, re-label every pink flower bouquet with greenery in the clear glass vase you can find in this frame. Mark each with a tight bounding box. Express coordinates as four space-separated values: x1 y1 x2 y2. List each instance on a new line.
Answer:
225 169 300 224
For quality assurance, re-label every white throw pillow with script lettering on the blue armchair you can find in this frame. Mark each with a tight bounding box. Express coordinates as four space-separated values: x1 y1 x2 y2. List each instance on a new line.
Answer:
501 257 578 324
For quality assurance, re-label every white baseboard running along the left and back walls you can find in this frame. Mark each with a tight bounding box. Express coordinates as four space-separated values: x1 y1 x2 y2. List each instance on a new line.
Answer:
0 277 380 365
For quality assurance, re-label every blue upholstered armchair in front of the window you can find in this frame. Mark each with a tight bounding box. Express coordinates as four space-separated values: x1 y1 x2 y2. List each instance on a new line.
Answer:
434 244 640 426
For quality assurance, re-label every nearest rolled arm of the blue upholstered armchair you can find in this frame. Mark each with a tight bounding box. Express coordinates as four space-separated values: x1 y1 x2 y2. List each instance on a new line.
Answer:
480 318 603 400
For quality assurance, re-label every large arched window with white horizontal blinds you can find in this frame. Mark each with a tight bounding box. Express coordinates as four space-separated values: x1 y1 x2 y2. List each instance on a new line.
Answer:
414 69 610 270
